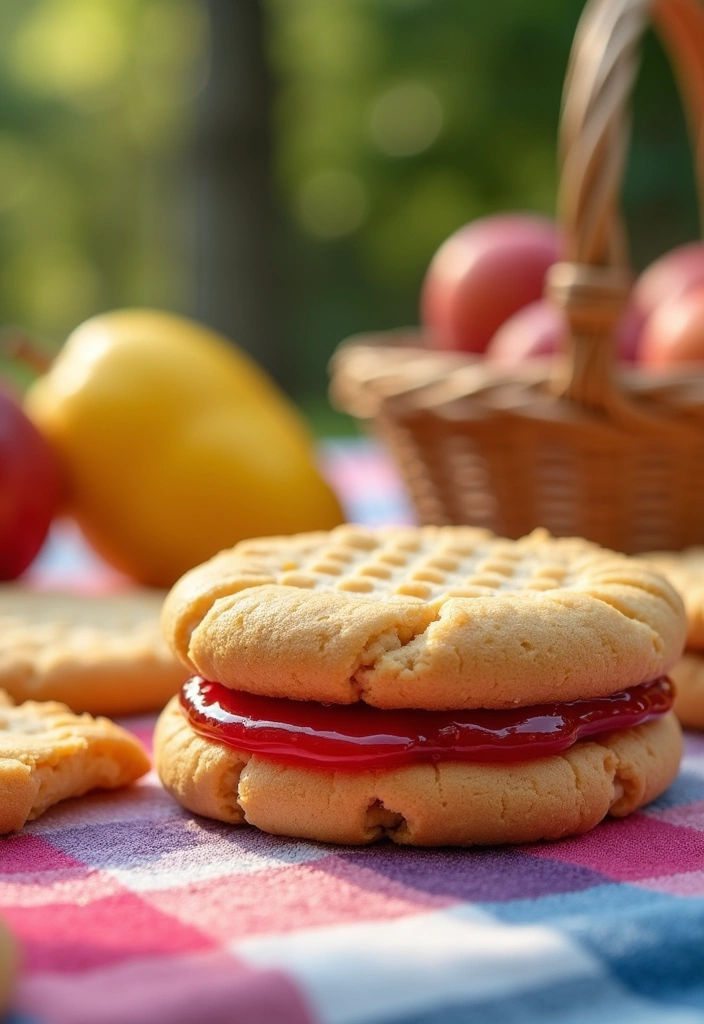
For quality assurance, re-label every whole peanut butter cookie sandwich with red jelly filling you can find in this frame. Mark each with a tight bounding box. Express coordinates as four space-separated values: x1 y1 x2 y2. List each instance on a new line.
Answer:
156 526 687 846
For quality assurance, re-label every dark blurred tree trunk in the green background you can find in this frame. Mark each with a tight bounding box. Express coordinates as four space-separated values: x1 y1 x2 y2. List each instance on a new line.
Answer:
194 0 290 386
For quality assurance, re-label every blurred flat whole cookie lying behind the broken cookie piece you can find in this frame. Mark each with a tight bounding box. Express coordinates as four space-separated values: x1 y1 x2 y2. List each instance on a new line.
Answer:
0 584 187 715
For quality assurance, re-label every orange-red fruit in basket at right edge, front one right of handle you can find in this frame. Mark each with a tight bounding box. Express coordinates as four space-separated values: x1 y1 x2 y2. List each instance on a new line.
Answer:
641 283 704 367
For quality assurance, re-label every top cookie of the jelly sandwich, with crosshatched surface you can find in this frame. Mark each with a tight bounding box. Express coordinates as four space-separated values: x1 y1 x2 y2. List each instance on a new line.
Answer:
162 526 687 710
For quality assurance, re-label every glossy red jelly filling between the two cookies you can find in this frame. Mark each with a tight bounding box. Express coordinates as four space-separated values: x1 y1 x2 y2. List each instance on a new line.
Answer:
181 676 673 771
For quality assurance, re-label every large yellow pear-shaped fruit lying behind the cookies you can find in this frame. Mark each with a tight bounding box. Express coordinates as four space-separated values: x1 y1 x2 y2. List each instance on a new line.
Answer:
26 309 342 586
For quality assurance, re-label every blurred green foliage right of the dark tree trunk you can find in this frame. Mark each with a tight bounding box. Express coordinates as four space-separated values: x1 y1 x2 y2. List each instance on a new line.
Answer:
269 0 697 399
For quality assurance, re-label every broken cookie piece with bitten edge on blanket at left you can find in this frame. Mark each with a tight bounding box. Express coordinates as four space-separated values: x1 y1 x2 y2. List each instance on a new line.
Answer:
0 690 149 835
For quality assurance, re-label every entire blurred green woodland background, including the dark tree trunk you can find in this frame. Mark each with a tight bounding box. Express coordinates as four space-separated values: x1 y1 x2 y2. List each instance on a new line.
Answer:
0 0 697 432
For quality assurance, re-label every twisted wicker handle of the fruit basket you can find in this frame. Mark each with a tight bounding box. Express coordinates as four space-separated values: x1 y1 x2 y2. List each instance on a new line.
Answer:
546 0 704 411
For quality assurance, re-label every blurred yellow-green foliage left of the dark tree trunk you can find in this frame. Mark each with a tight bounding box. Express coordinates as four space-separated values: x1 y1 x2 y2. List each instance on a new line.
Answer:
0 0 207 343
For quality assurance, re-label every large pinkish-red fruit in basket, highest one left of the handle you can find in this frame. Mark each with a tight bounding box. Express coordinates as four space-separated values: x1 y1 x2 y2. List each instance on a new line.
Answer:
421 213 560 352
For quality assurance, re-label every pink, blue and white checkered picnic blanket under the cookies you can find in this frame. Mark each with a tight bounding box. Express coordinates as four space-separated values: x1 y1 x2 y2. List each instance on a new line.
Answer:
0 445 704 1024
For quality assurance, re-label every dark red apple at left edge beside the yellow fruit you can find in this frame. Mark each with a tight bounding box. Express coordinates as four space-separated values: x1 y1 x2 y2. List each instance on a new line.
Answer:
0 389 60 580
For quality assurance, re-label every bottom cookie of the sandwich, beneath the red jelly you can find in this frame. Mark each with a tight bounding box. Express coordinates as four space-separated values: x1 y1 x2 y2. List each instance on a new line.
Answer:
155 698 681 846
